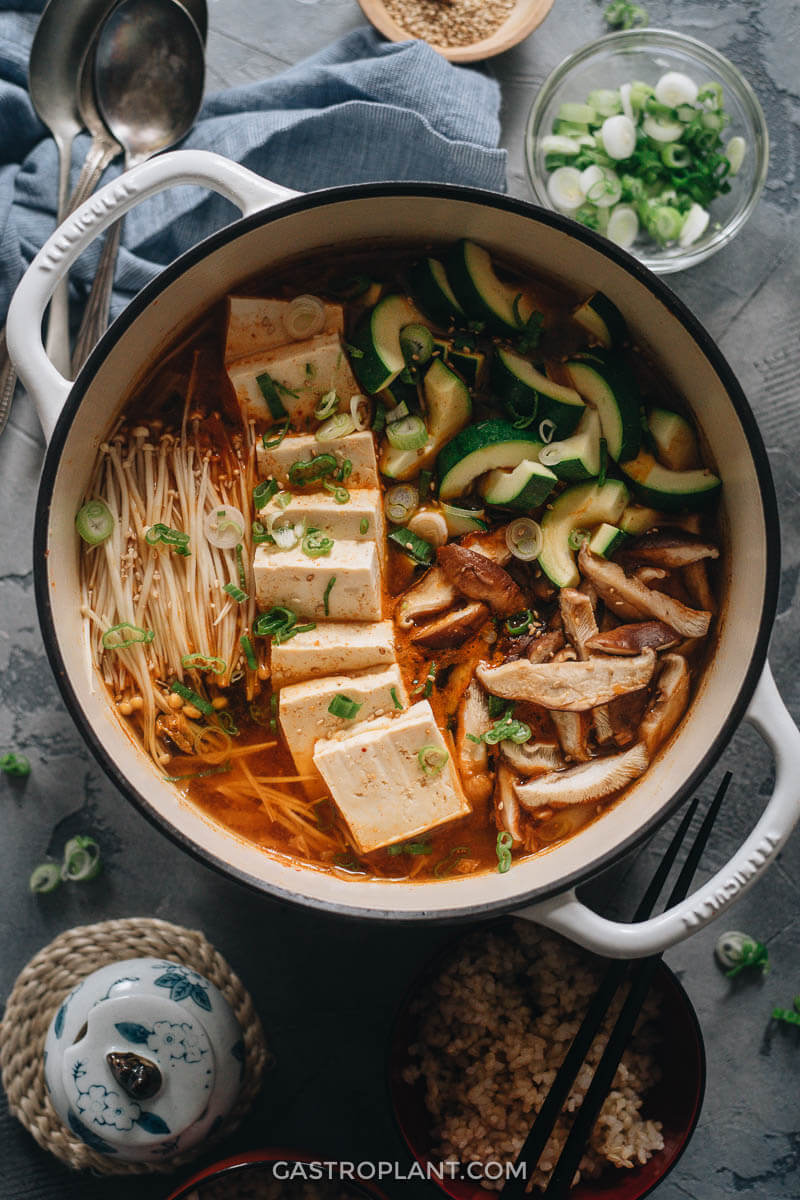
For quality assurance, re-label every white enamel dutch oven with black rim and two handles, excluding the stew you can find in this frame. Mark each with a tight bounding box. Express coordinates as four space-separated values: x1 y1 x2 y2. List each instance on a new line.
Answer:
7 151 800 956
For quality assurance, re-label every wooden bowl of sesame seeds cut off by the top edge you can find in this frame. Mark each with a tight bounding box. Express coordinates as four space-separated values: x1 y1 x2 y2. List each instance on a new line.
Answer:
359 0 553 62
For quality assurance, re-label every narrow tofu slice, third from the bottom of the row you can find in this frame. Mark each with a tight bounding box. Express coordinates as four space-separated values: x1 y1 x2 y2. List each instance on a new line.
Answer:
270 619 397 689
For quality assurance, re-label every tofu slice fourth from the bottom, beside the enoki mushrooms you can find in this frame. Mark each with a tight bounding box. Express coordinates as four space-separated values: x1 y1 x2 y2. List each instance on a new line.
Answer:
253 541 381 620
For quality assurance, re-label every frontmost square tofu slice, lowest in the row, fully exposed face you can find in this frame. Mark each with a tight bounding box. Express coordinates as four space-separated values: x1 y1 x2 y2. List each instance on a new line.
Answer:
313 700 470 854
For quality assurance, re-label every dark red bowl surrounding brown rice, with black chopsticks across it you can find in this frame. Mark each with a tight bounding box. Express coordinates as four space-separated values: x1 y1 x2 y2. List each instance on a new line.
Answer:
389 938 705 1200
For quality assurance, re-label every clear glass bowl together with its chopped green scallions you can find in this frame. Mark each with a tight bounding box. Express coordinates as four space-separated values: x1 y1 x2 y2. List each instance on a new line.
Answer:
525 29 769 275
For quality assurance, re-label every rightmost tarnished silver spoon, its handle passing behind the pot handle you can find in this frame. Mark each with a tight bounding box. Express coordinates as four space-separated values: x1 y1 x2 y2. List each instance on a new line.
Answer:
72 0 205 373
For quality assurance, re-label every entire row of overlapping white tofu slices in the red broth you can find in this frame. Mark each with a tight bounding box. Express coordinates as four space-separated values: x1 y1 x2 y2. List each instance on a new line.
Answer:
225 296 470 853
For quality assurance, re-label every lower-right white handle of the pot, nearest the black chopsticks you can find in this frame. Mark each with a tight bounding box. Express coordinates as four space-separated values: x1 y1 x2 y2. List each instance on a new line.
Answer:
515 665 800 959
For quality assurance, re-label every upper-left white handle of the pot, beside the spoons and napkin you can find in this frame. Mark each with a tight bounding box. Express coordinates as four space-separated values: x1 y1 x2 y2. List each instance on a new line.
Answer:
6 150 300 442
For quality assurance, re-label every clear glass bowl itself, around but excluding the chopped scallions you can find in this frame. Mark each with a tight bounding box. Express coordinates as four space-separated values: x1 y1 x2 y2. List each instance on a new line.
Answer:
525 29 769 275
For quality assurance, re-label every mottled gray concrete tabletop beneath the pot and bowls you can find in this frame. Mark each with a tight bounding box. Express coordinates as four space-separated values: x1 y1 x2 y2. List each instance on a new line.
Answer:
0 0 800 1200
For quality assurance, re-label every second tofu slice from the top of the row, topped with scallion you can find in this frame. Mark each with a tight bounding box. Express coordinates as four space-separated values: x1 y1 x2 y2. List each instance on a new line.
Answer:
228 334 361 429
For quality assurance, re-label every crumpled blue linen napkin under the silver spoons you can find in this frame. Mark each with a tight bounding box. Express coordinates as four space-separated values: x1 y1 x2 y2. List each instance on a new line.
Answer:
0 0 506 322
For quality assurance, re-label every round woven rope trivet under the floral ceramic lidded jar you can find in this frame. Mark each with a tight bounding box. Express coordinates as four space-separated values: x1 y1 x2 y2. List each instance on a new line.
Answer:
0 918 266 1175
